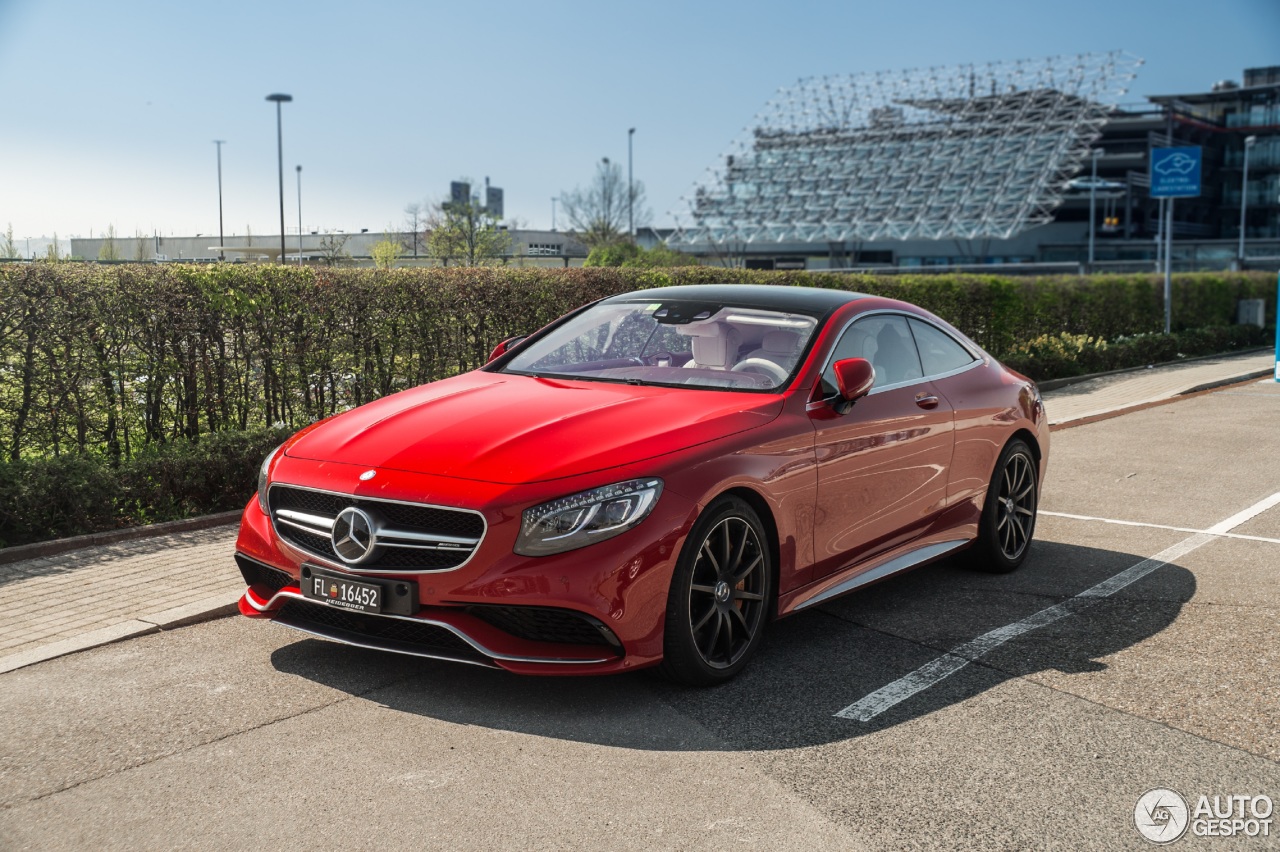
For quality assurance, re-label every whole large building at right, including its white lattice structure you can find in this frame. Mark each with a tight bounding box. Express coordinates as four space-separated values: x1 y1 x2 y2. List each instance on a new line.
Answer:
665 52 1280 270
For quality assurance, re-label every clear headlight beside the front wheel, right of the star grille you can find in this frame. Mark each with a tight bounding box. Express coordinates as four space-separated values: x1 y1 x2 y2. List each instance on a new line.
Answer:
516 478 662 556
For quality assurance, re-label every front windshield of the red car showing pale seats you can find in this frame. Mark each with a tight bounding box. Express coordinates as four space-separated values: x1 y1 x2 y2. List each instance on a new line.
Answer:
502 296 818 390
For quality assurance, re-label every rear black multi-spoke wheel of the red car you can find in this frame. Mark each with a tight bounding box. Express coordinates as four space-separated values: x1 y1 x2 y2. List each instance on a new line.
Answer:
968 440 1039 574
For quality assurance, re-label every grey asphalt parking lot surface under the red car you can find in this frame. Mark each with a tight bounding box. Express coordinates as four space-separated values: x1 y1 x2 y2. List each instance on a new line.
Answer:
0 380 1280 849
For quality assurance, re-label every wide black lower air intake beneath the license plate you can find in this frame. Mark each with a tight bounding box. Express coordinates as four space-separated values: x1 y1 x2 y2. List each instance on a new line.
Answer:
275 600 489 664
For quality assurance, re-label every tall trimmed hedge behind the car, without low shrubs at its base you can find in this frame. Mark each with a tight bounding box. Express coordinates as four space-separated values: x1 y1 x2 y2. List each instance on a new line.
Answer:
0 264 1275 466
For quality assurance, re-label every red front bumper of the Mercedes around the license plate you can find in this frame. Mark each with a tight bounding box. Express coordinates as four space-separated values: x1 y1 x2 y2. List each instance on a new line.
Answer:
236 457 696 674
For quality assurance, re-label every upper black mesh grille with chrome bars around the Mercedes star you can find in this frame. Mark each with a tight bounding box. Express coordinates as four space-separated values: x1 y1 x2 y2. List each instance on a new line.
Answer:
268 485 485 572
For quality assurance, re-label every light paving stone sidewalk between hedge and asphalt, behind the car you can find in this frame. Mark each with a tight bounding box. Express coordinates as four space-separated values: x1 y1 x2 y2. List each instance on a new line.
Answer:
0 345 1275 673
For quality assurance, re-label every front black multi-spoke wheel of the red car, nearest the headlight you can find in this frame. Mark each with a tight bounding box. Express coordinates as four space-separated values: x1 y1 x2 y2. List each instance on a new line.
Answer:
662 498 773 686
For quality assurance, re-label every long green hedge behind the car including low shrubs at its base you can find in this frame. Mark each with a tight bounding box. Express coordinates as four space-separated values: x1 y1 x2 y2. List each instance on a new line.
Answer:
0 264 1276 544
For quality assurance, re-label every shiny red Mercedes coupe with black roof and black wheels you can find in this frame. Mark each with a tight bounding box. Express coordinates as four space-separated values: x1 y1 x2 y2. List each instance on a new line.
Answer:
236 285 1048 684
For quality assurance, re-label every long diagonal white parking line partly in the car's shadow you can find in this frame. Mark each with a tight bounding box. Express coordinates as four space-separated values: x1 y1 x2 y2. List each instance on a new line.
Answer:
835 493 1280 722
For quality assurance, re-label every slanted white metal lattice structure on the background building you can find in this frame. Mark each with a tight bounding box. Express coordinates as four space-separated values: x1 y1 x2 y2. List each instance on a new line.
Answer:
668 51 1142 247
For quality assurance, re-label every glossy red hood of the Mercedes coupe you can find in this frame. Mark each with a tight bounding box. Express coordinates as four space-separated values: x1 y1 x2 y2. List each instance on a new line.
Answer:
285 371 782 485
